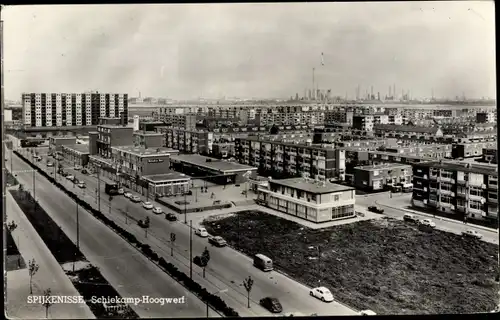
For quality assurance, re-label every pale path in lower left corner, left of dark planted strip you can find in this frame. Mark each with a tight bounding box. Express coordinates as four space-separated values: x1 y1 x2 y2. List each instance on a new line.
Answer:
6 192 95 319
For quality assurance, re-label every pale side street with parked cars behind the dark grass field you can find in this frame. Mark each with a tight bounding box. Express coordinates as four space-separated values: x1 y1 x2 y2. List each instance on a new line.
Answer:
356 193 499 245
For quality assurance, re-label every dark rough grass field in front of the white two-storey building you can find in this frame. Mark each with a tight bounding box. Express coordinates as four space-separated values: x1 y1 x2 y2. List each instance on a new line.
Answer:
204 211 499 314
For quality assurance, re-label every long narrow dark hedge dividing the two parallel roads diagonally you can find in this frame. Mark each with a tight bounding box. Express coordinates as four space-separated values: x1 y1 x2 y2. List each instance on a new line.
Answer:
14 151 239 317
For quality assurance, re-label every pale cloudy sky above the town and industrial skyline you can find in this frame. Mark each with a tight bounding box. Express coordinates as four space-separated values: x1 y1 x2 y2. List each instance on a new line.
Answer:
2 1 496 100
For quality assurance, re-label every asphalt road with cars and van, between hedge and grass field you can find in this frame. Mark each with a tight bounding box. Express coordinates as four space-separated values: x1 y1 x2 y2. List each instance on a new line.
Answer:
25 148 357 316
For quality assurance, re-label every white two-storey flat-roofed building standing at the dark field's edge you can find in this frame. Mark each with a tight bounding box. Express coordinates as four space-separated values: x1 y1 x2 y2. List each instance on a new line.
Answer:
257 178 356 223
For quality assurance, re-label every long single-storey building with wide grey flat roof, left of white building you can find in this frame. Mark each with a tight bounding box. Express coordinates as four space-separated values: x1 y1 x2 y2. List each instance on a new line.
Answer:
170 154 257 184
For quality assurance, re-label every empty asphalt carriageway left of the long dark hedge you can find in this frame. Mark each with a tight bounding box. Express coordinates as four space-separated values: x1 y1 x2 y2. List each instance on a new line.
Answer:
9 151 218 318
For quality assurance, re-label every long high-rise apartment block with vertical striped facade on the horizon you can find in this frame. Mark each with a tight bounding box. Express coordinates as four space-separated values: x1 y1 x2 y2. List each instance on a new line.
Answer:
22 93 128 127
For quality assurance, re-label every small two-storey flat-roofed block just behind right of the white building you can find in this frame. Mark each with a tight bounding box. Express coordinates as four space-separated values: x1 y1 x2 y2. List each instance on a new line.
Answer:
354 163 412 191
